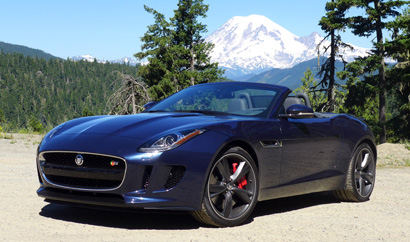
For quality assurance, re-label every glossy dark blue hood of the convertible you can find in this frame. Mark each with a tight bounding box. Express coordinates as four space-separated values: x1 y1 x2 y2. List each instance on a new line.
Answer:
58 113 237 140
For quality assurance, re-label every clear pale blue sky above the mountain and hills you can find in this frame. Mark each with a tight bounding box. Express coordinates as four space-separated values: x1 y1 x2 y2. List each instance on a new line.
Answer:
0 0 371 60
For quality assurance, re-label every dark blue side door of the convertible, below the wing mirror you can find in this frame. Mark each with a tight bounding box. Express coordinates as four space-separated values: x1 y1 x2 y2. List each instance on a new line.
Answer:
280 117 342 192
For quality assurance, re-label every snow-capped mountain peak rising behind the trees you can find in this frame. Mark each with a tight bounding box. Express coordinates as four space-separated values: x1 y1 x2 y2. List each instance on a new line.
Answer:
205 15 369 77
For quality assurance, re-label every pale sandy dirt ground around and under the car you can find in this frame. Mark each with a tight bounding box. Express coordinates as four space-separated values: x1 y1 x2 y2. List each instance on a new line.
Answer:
0 135 410 241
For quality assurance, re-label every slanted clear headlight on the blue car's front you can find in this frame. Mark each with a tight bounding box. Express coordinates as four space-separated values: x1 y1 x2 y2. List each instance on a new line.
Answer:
138 129 205 153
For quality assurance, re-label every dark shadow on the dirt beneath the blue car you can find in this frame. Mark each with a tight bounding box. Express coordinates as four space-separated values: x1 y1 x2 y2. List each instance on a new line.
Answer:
39 193 338 230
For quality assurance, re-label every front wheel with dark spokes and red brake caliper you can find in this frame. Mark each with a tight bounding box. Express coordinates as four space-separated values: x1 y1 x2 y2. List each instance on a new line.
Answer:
192 147 259 227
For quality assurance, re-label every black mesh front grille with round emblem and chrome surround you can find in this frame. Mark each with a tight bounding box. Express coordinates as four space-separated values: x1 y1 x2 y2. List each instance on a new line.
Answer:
39 152 126 190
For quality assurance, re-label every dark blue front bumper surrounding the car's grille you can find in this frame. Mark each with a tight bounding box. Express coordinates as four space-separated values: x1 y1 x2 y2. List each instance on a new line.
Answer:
37 132 226 210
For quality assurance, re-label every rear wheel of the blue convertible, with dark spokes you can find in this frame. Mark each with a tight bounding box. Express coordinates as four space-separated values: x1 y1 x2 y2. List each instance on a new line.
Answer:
333 143 376 202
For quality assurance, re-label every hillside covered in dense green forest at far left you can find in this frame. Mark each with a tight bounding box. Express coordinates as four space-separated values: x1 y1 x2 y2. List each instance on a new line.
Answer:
0 53 137 130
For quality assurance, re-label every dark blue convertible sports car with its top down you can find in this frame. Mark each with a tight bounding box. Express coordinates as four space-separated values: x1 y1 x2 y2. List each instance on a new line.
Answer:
37 82 376 226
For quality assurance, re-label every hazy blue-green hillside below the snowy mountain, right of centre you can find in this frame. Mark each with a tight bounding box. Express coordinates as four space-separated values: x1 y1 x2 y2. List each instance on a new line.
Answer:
247 59 343 89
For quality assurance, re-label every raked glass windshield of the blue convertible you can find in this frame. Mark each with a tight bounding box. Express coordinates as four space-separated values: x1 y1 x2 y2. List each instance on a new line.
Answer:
148 82 280 117
